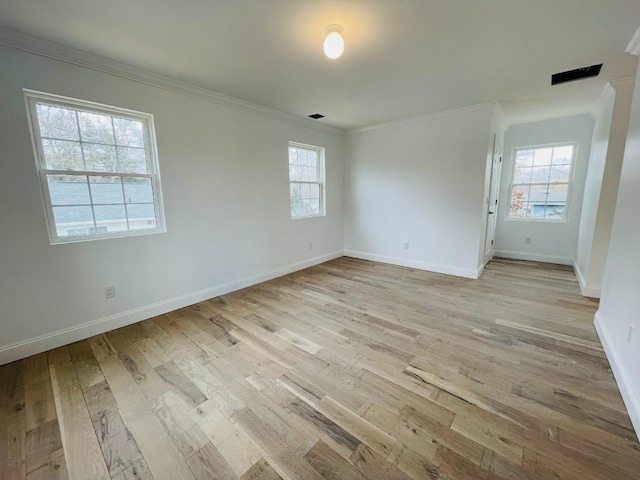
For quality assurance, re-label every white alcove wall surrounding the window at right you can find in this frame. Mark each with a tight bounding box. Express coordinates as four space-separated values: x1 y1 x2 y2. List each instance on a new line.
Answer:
496 115 594 265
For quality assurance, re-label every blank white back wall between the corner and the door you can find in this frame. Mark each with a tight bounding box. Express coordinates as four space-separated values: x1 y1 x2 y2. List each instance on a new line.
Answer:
345 105 494 278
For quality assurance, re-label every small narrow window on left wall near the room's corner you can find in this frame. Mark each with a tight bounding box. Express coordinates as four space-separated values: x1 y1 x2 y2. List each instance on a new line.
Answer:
289 143 325 218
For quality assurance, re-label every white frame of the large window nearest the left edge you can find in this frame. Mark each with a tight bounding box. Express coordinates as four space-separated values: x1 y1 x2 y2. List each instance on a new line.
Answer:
24 89 167 245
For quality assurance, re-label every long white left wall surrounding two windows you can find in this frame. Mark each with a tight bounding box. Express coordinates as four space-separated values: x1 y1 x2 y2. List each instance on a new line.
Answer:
0 47 344 364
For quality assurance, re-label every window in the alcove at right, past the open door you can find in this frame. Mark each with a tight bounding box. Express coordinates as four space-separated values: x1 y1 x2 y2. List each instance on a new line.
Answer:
508 144 575 221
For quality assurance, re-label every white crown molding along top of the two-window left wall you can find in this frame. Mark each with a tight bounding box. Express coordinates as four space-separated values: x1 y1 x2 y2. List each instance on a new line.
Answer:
0 27 344 134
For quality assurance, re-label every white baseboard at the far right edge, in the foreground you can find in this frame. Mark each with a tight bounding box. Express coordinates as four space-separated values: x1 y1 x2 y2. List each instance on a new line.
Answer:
594 310 640 440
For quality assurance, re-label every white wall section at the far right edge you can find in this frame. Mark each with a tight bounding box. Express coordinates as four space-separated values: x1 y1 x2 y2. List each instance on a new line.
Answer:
596 58 640 433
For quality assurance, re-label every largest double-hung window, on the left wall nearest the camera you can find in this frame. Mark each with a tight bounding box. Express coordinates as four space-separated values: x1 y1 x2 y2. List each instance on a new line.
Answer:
25 91 165 244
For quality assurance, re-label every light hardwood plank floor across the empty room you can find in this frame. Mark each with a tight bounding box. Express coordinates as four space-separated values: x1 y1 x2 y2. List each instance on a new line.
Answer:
0 258 640 480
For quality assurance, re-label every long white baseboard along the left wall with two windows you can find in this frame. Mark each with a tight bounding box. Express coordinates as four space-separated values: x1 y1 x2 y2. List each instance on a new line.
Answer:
0 251 343 365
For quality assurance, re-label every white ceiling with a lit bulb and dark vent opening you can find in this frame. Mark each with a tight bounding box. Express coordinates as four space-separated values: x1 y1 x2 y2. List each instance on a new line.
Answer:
0 0 640 128
